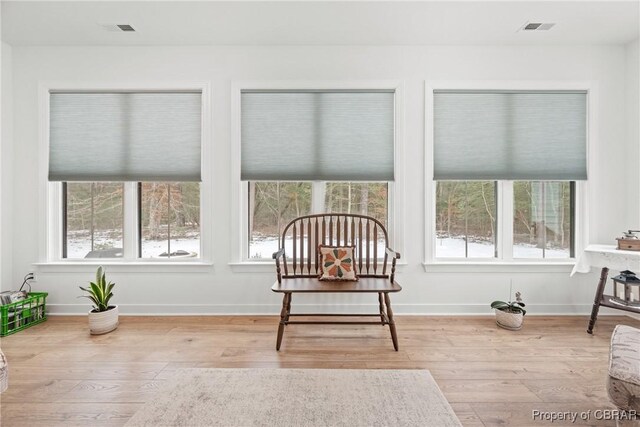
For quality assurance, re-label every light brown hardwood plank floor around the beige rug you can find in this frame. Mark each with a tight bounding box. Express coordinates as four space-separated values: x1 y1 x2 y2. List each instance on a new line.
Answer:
0 316 640 426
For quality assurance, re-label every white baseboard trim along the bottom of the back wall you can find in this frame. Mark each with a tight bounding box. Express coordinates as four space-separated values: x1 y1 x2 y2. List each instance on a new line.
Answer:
47 304 608 316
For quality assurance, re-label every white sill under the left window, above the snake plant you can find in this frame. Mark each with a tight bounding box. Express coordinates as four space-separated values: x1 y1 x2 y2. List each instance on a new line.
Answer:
32 260 213 273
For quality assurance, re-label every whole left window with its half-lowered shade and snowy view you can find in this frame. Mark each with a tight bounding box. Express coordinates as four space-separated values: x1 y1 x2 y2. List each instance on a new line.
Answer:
49 89 203 261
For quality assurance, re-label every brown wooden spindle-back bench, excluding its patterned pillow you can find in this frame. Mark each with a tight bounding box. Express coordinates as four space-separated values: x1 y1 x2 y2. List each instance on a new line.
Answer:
271 214 402 351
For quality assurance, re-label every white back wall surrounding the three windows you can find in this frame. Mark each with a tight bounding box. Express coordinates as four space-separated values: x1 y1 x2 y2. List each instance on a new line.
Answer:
3 46 640 313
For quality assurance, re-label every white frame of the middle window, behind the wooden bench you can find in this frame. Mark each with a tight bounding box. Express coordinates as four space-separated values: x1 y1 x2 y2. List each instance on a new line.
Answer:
229 80 405 272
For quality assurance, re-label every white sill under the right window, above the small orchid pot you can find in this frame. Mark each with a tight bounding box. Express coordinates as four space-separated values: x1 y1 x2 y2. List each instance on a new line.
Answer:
422 260 575 274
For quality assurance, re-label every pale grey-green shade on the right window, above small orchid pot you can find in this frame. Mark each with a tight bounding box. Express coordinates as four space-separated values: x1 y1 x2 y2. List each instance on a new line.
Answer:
434 91 587 180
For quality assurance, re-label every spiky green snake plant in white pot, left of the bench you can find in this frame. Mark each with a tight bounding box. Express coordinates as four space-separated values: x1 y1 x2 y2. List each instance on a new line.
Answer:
78 267 118 335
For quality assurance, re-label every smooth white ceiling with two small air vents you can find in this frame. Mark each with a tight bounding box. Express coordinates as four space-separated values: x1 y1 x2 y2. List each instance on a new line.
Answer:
1 0 640 45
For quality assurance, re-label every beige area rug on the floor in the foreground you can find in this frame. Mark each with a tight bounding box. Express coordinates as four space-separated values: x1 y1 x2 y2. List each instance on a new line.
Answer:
126 369 461 427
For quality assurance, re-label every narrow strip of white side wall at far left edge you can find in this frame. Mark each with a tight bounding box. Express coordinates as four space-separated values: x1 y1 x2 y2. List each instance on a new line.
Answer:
0 43 15 290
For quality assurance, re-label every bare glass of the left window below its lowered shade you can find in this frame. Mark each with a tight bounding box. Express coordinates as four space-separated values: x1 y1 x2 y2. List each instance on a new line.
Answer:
62 182 200 260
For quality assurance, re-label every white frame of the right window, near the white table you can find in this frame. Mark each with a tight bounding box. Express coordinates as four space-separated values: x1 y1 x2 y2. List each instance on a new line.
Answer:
423 80 598 272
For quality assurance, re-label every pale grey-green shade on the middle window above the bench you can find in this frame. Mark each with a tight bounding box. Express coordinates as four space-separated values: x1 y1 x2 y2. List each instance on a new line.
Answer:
241 91 394 181
